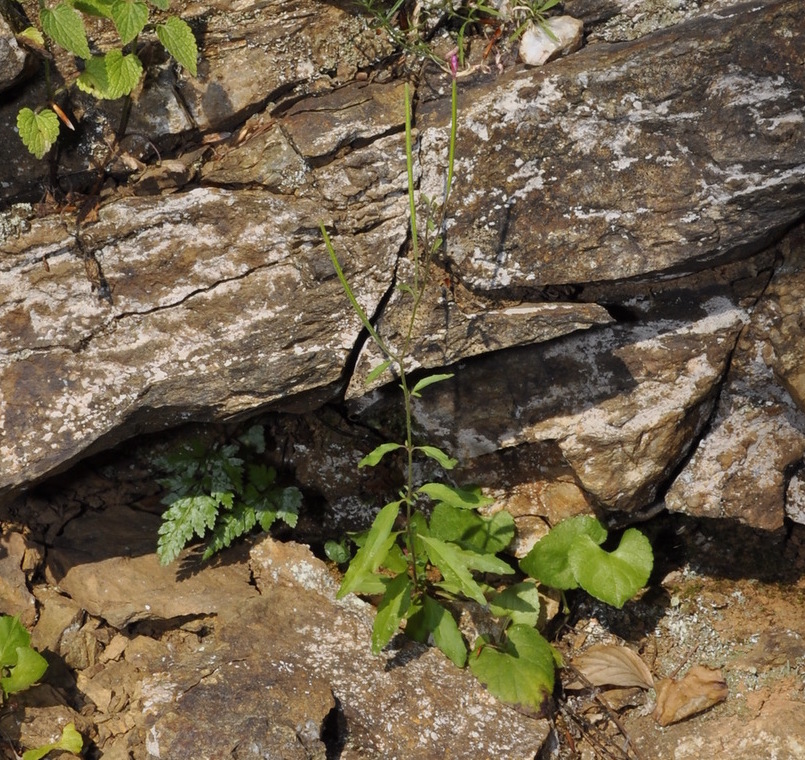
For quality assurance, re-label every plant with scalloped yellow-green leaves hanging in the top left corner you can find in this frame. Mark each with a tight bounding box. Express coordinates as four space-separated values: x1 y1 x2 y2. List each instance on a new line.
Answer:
17 0 198 158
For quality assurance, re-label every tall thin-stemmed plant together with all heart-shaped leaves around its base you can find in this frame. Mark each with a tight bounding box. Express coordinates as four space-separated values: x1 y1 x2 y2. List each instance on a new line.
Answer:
321 63 653 711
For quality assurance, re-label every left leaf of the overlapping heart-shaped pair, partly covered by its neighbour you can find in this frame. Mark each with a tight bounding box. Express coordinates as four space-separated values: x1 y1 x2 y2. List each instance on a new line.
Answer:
520 515 607 590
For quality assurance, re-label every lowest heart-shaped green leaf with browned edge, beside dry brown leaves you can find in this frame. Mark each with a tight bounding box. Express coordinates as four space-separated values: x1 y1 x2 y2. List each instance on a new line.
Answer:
469 625 556 713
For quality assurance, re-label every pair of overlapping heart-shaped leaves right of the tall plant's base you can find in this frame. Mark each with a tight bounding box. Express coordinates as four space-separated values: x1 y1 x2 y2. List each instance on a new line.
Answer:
520 516 654 608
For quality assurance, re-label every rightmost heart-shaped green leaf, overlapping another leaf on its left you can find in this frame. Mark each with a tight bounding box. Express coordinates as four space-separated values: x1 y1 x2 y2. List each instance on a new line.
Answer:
568 528 654 608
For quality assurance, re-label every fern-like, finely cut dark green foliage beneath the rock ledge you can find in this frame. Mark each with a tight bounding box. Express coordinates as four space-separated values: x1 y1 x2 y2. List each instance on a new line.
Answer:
154 425 302 565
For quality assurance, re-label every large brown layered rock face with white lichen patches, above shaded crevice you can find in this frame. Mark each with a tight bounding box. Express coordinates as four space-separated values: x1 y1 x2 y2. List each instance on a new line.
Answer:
0 0 805 528
